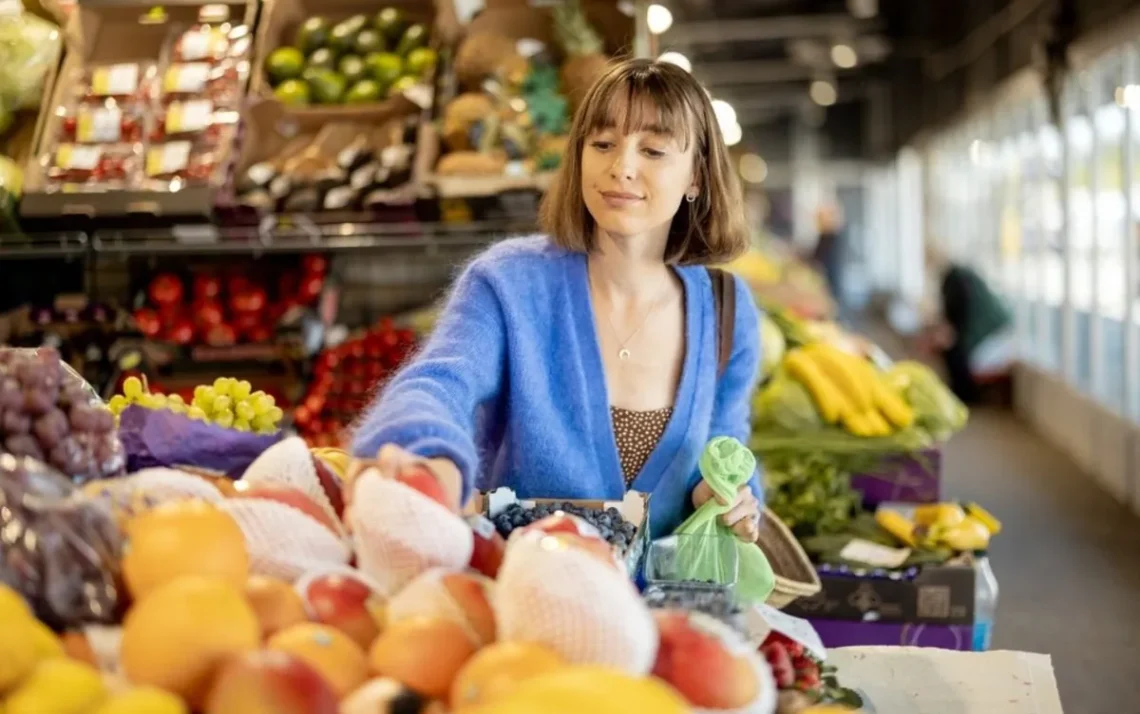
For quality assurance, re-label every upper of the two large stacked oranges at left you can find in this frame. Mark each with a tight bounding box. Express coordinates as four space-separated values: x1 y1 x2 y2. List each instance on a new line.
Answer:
122 501 250 600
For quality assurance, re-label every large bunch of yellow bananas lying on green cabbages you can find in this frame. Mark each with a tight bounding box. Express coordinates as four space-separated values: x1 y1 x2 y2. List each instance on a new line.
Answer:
784 343 914 437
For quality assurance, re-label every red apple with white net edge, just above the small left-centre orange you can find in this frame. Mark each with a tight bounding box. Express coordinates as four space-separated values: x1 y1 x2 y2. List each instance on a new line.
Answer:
299 573 385 651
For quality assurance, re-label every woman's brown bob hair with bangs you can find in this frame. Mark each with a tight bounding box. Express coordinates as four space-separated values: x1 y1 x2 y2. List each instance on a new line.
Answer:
539 59 750 265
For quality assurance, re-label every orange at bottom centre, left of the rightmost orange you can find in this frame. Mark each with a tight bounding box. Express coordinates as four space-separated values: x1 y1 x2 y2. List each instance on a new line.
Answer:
368 616 478 699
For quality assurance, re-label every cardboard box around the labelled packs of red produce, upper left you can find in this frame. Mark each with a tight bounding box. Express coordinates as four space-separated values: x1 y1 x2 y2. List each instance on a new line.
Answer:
21 0 258 218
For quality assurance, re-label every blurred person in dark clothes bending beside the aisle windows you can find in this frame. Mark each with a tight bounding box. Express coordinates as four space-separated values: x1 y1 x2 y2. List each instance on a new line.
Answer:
922 241 1013 404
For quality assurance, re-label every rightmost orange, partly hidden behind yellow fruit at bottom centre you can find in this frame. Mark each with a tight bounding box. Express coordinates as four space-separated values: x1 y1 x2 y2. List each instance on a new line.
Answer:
450 642 567 708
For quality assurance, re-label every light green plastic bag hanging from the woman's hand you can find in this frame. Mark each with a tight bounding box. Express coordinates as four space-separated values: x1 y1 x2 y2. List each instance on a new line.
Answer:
676 437 775 605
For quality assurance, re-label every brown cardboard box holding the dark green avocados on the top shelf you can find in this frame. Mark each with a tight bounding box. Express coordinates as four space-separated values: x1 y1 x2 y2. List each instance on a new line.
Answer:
250 0 437 131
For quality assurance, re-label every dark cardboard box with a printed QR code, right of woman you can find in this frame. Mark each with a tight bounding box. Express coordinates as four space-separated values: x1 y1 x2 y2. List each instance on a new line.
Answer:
784 566 976 625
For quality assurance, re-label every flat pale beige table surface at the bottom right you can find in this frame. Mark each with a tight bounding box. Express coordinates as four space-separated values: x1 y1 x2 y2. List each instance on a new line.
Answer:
828 647 1061 714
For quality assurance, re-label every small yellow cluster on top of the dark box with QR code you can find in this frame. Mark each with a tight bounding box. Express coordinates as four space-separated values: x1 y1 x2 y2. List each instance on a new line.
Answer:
874 503 1001 552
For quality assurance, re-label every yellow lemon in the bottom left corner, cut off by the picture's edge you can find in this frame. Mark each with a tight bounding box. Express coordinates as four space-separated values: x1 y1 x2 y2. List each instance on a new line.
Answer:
5 658 107 714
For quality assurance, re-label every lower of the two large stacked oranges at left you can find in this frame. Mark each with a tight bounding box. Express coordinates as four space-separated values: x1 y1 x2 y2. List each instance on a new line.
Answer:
120 575 261 706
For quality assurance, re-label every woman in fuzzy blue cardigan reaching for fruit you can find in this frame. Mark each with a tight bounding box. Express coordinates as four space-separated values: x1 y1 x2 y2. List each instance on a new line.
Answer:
353 59 760 539
